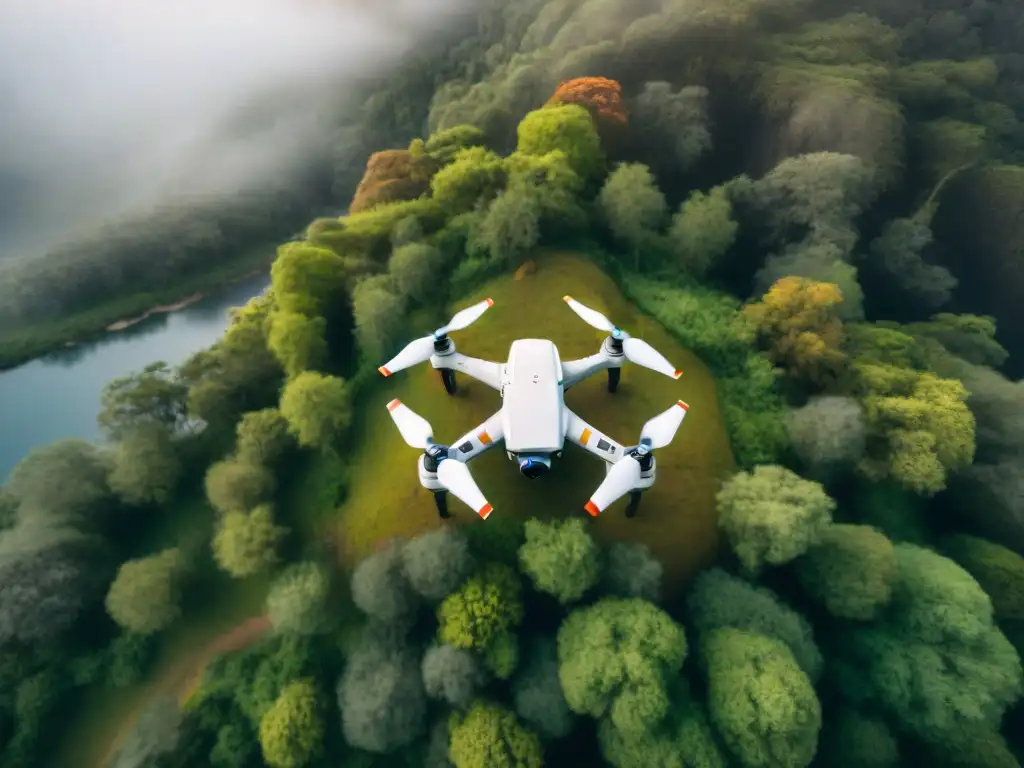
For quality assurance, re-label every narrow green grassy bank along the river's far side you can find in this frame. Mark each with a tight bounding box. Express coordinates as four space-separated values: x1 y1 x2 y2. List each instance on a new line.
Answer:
0 245 275 371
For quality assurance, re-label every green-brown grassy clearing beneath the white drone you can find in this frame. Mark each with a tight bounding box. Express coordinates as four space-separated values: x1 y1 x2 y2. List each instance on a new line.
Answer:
330 254 733 592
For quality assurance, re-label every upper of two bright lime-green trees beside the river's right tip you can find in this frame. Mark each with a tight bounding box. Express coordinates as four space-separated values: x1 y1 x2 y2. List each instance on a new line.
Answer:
270 242 347 317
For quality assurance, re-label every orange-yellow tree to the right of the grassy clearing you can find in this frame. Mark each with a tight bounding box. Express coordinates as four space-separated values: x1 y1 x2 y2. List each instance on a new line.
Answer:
743 276 846 385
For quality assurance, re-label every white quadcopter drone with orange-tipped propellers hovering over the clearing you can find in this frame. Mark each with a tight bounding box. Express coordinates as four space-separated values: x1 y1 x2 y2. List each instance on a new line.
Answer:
378 296 689 519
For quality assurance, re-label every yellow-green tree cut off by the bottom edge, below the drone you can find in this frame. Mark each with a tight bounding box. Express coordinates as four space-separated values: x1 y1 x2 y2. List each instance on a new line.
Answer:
449 701 544 768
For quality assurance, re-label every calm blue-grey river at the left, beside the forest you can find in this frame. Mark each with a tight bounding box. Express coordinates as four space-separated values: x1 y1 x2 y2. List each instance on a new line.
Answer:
0 275 269 482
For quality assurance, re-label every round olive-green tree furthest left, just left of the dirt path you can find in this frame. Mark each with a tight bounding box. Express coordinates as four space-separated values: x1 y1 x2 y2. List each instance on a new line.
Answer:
109 423 181 505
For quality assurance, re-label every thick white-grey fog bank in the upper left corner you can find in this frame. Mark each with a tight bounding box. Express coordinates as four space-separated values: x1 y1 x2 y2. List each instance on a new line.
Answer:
0 0 469 258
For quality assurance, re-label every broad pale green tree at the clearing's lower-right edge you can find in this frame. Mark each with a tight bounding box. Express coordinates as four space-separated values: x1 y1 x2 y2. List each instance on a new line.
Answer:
717 465 836 572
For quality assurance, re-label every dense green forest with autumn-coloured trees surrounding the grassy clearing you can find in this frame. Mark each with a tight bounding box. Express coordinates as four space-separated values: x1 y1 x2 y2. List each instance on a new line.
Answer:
0 0 1024 768
